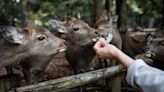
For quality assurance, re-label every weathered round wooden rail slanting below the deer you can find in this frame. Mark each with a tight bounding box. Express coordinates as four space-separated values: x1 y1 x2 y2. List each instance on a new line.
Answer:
9 65 125 92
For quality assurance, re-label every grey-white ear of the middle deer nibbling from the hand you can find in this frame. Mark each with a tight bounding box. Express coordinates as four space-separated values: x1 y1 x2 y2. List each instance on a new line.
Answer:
48 19 67 34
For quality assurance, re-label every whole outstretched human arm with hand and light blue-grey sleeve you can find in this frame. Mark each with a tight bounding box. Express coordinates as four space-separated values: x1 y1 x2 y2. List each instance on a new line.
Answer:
94 39 164 92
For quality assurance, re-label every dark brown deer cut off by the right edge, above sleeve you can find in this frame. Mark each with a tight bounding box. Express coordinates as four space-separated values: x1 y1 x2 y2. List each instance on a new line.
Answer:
144 32 164 70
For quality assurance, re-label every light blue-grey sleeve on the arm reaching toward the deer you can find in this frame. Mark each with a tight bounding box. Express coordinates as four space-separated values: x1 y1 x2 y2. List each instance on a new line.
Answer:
126 59 164 92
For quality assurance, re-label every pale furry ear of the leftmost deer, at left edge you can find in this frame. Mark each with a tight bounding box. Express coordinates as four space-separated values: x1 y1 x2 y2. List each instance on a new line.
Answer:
0 26 23 44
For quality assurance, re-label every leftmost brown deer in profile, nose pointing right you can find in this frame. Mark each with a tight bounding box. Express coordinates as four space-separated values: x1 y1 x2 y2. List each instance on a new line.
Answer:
0 22 64 83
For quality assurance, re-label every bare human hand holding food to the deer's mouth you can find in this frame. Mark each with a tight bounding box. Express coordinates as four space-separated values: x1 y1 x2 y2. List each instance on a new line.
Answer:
93 38 118 59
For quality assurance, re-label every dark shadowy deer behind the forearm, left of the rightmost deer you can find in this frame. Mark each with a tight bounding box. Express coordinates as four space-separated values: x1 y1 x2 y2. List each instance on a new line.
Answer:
124 31 151 58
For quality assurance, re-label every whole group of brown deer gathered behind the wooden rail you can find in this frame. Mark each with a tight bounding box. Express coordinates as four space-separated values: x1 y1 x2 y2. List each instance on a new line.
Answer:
0 12 164 87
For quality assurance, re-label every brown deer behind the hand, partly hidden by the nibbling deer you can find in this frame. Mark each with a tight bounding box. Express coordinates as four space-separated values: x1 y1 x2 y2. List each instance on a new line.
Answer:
94 10 122 49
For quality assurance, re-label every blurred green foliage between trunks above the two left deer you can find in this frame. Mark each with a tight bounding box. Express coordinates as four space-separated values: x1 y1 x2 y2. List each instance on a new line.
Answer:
28 0 93 25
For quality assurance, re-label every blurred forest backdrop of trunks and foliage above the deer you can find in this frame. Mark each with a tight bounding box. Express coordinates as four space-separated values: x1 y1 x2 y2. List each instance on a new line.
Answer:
0 0 164 30
